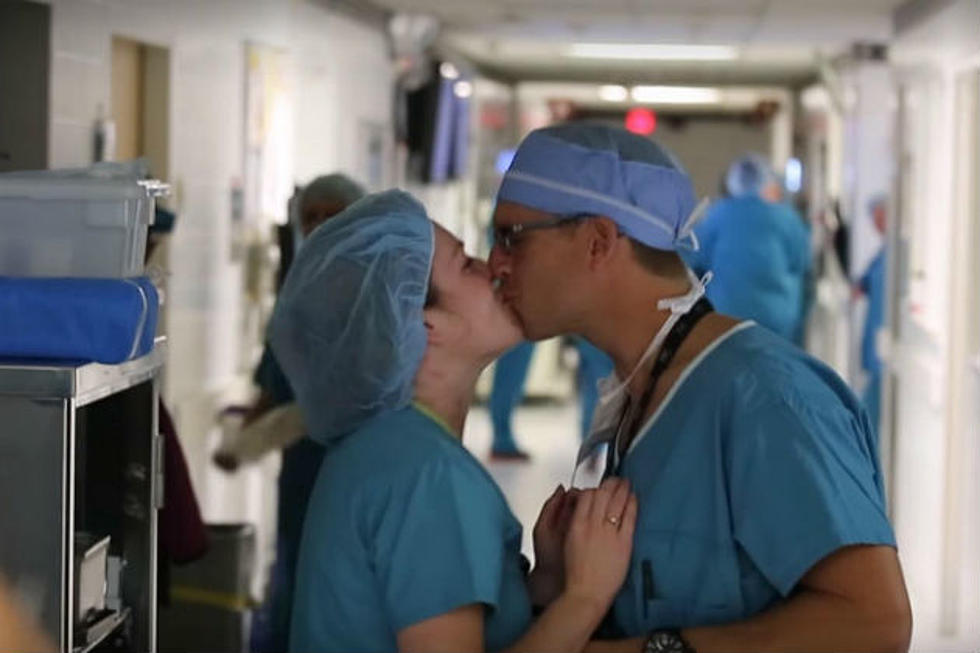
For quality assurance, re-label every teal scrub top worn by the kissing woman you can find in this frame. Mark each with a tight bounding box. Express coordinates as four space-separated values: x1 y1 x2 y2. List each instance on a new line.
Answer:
290 405 531 652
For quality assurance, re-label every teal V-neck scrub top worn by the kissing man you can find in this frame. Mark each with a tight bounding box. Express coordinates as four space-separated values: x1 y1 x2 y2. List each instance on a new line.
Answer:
613 323 895 636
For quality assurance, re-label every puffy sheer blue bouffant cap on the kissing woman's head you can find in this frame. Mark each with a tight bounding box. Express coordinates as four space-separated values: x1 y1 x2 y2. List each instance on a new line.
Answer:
269 191 435 443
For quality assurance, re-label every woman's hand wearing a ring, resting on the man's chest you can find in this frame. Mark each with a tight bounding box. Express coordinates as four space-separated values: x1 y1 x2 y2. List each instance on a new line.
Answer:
564 478 637 611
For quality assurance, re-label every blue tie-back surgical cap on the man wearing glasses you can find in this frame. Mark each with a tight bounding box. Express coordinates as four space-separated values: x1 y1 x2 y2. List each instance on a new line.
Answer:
497 123 697 250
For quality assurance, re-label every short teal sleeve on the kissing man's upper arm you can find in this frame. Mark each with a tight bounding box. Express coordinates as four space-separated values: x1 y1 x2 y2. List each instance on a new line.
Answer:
726 398 895 596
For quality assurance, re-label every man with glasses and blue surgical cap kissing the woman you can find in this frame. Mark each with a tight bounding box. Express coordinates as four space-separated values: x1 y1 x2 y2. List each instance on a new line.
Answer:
491 124 911 653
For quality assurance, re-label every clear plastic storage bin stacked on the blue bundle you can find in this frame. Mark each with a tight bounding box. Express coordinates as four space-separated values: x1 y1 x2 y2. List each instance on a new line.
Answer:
0 172 167 278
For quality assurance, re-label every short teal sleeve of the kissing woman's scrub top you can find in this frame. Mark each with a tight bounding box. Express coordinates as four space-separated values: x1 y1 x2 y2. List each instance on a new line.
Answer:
373 460 505 631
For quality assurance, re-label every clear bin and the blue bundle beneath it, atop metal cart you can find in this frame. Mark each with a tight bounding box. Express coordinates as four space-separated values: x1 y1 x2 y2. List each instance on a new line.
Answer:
0 161 168 363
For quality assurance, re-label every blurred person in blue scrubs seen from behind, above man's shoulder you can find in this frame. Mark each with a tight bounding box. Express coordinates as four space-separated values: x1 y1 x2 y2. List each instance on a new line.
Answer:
682 154 810 344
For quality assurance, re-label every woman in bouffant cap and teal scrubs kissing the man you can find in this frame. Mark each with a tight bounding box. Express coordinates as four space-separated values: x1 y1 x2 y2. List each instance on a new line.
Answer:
269 191 637 652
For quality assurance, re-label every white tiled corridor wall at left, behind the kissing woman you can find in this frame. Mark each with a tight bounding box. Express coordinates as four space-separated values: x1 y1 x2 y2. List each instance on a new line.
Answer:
41 0 392 592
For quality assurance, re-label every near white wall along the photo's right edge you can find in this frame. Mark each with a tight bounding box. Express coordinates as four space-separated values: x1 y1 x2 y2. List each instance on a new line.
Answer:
885 0 980 651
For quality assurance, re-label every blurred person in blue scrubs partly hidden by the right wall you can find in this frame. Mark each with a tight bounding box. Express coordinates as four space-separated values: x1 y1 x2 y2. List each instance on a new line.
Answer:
856 195 888 433
